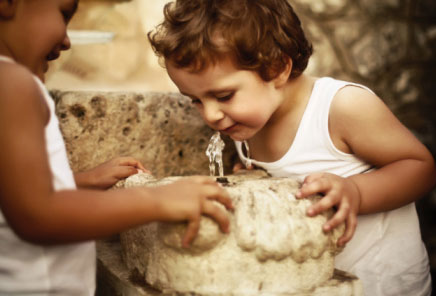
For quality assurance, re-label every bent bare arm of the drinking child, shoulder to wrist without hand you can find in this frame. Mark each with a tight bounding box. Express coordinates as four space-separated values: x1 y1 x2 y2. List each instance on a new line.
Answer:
330 87 436 214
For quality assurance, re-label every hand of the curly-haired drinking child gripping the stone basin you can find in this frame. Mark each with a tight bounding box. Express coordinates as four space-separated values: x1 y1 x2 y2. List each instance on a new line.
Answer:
297 173 360 246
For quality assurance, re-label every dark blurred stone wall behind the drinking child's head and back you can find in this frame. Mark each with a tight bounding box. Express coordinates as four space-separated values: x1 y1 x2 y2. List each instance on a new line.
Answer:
291 0 436 153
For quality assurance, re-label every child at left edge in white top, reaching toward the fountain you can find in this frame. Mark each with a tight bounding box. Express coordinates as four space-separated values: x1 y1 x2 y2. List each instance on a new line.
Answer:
0 0 231 295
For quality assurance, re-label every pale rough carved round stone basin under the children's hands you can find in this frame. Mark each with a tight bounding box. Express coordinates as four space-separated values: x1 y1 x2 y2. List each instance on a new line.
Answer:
116 174 362 296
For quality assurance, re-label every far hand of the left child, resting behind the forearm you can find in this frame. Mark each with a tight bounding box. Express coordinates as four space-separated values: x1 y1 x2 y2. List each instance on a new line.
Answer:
74 157 150 189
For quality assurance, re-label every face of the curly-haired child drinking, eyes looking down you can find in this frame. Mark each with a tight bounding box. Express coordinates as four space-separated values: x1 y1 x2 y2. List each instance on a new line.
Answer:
166 60 281 141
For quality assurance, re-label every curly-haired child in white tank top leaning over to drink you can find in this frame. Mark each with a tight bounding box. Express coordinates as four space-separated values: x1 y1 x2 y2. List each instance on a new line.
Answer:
148 0 435 296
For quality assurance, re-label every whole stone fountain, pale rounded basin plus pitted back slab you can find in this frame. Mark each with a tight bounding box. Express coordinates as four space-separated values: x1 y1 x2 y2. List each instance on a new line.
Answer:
53 92 363 296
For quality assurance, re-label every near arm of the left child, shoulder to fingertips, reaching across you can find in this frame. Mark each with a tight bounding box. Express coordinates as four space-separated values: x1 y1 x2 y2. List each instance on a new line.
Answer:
0 67 231 245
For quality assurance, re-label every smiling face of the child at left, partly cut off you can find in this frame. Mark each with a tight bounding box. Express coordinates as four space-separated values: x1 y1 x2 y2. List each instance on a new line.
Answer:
5 0 78 80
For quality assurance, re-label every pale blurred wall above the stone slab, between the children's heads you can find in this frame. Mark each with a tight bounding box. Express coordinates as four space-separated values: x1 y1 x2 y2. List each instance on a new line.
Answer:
46 0 177 92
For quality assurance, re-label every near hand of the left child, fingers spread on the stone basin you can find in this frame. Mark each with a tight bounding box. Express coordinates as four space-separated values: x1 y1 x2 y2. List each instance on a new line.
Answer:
152 176 233 247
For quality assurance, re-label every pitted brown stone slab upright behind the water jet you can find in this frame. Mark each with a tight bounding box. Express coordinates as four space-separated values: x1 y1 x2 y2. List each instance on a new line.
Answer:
52 91 235 177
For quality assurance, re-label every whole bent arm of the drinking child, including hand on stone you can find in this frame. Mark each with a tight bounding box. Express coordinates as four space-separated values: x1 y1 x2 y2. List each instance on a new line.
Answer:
299 87 436 216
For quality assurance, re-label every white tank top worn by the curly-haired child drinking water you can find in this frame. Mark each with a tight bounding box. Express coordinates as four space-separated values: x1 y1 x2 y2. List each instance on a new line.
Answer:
235 77 431 296
